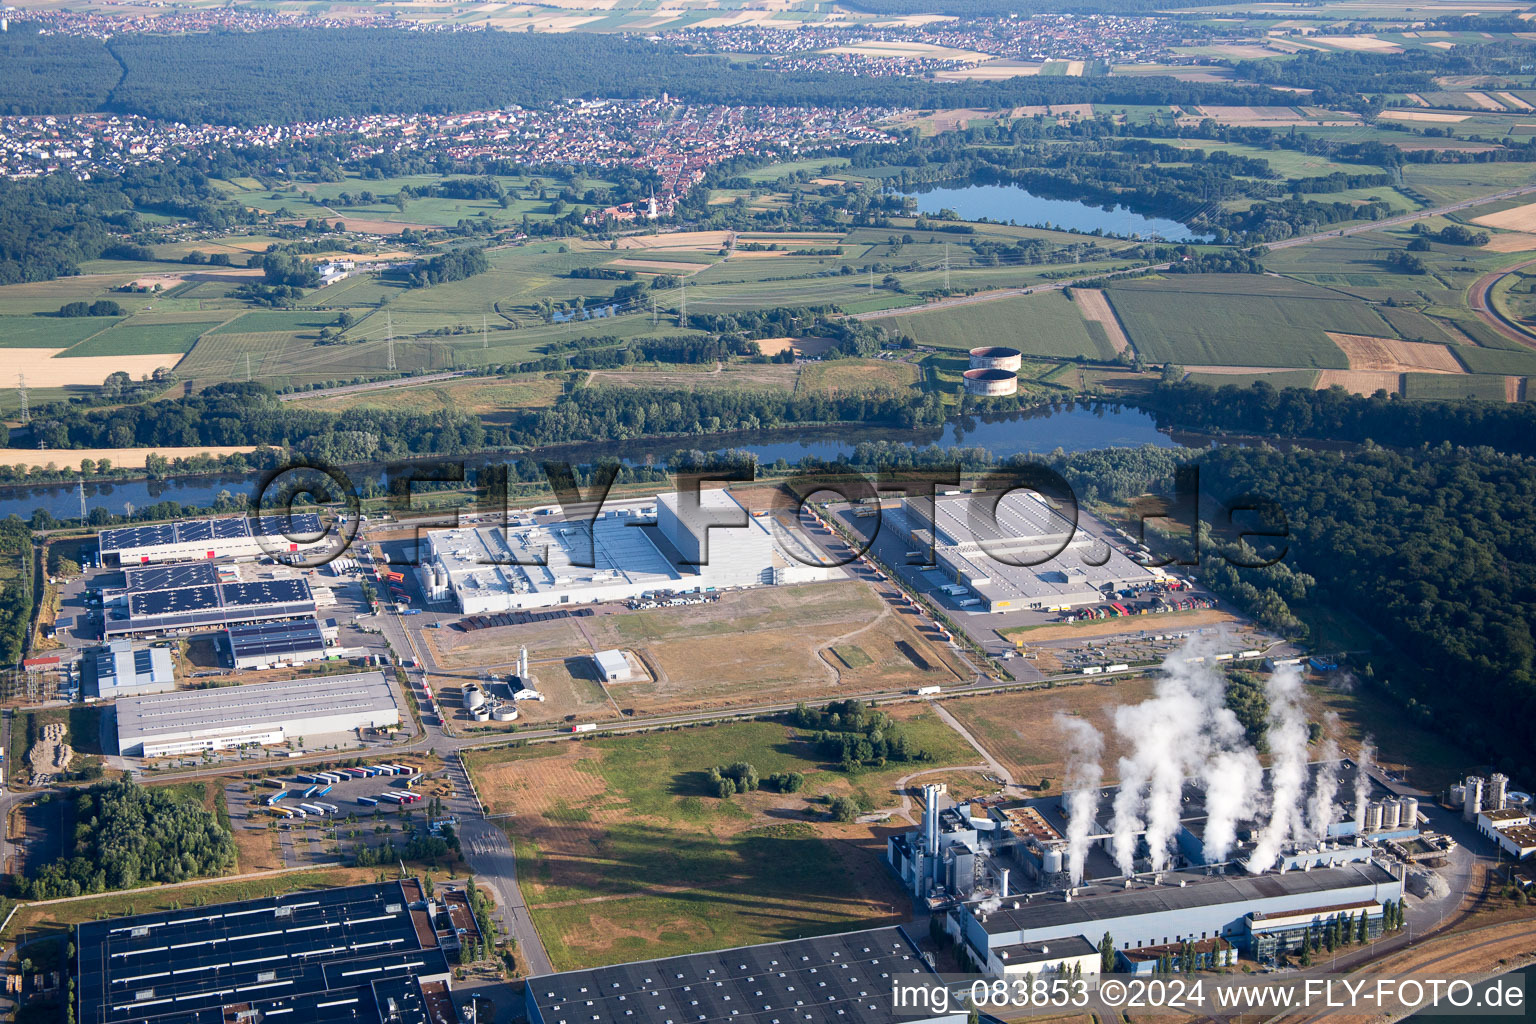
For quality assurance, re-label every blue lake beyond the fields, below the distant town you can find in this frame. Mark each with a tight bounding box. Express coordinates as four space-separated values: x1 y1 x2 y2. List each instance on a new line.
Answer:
905 184 1210 241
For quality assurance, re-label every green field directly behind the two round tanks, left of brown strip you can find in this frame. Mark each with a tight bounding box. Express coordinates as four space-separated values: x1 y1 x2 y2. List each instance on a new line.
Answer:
874 292 1115 359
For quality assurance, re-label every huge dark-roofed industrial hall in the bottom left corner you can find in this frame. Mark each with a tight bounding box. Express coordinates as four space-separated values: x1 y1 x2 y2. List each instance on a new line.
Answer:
74 878 461 1024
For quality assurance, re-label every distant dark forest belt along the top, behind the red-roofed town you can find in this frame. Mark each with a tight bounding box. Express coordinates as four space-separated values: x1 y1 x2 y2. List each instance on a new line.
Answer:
0 29 1308 126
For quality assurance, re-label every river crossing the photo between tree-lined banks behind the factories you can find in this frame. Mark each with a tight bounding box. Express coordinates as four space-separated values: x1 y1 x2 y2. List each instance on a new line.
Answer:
0 405 1181 519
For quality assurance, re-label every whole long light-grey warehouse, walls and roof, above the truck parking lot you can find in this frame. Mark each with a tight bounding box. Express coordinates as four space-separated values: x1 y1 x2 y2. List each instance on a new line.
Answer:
117 672 399 757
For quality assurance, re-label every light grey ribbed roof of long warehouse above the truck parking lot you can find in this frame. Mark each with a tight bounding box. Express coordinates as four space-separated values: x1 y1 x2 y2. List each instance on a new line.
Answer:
117 672 396 751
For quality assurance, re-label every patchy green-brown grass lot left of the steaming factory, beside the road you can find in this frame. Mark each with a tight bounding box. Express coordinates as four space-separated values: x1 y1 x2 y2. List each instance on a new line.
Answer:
465 706 977 970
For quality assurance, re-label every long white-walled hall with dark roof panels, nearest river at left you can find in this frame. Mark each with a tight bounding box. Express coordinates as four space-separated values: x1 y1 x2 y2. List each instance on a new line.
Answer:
98 513 324 565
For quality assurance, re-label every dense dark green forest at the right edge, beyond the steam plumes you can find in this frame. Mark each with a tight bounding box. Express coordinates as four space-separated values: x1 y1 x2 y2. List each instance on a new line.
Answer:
1200 445 1536 775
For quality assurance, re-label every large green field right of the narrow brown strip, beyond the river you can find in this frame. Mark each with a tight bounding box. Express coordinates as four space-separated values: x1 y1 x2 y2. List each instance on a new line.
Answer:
1104 275 1392 370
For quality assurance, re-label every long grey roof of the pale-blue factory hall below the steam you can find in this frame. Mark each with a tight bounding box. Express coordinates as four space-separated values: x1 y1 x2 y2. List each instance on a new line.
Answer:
968 861 1395 935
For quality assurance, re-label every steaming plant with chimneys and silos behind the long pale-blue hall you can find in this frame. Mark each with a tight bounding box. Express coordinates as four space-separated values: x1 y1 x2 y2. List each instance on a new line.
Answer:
886 760 1419 914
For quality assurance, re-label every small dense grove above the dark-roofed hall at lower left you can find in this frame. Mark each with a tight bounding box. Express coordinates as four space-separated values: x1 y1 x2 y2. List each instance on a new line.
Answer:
17 777 235 900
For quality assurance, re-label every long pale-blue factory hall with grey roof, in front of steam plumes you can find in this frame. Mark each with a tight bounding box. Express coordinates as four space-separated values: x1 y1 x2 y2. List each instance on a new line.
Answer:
946 860 1402 973
